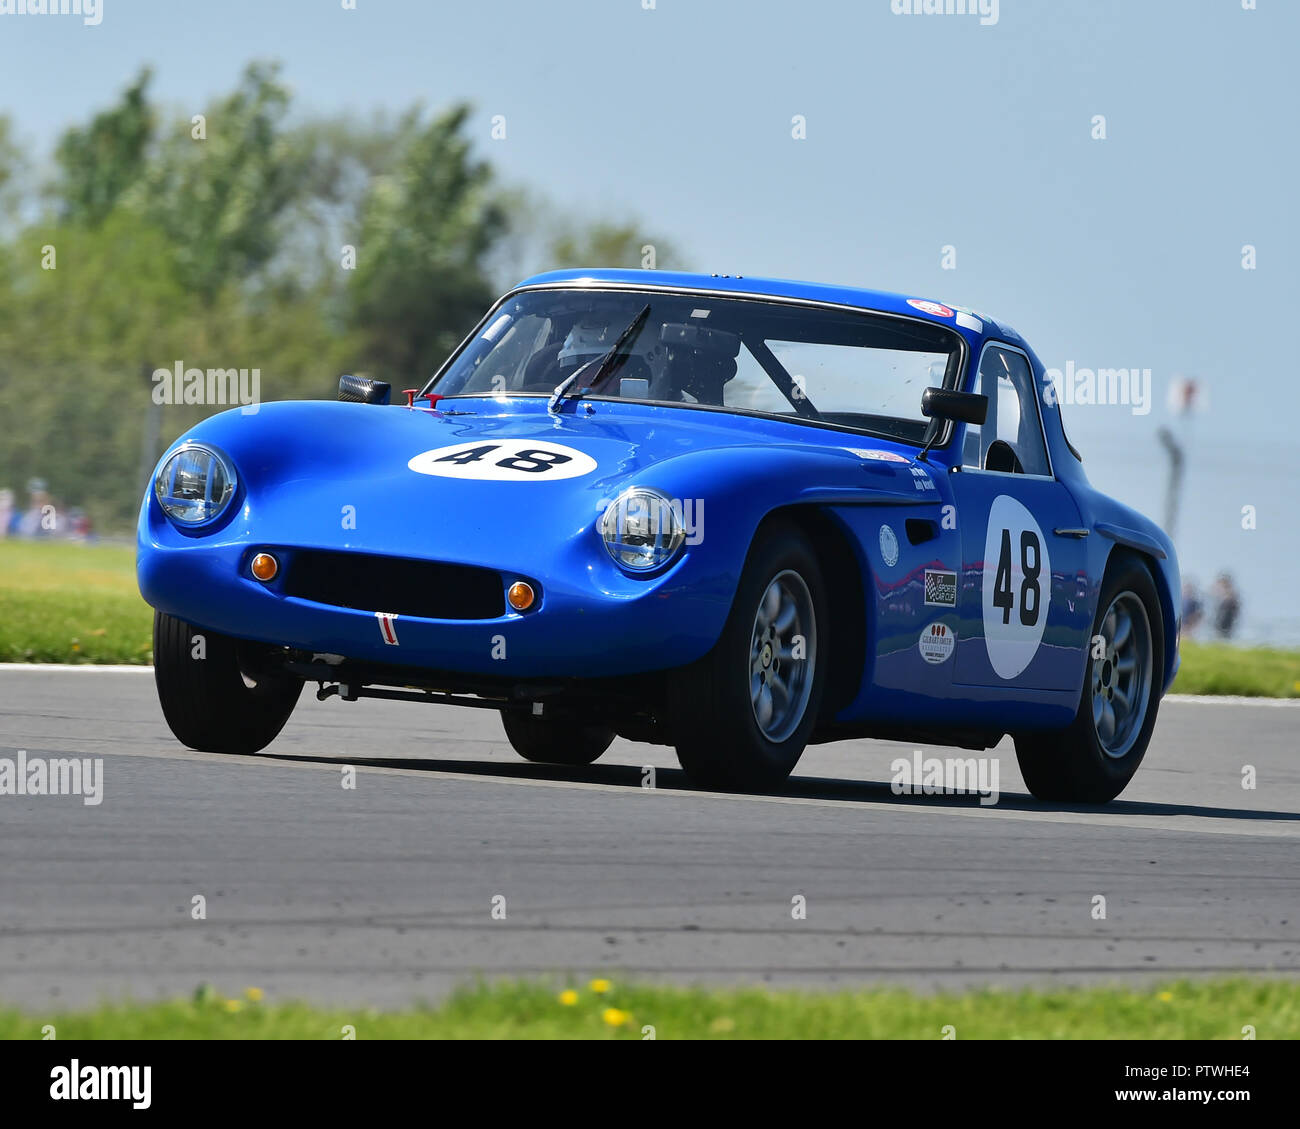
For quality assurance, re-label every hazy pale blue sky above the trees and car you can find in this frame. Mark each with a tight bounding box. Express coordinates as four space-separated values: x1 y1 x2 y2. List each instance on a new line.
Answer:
0 0 1300 643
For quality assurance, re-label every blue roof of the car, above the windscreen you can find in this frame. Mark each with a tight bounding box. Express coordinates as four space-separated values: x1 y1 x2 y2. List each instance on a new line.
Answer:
506 268 1019 341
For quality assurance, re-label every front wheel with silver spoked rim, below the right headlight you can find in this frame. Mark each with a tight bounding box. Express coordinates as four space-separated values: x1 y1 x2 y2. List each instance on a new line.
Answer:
668 523 828 791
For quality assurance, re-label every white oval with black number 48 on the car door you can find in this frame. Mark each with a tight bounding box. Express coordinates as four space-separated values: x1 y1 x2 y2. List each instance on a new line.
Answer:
983 494 1052 679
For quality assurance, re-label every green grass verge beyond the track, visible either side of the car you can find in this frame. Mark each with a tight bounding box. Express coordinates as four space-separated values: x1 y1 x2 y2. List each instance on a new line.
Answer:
0 541 1300 697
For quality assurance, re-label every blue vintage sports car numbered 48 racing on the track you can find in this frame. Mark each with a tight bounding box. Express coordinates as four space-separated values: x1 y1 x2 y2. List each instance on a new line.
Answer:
138 271 1180 803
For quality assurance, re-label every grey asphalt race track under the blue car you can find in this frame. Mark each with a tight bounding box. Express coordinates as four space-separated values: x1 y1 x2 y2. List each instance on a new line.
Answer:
0 667 1300 1008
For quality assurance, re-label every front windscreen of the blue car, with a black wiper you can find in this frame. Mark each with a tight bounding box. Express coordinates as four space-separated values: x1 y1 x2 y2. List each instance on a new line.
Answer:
433 289 961 444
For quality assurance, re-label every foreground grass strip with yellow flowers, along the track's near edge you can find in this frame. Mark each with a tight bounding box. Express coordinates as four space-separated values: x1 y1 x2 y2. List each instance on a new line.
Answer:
0 979 1300 1039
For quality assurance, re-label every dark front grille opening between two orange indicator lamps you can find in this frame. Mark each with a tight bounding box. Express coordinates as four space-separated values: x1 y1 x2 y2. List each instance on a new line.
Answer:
283 550 506 619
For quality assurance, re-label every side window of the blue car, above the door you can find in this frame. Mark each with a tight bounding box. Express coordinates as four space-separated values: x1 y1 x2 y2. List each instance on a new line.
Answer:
962 345 1050 475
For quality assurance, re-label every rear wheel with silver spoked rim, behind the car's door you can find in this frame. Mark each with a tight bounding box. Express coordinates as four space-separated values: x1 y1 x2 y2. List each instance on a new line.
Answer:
1015 555 1165 804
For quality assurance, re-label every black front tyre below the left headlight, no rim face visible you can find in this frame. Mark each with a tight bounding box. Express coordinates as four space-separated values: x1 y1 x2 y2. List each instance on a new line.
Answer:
153 611 303 753
